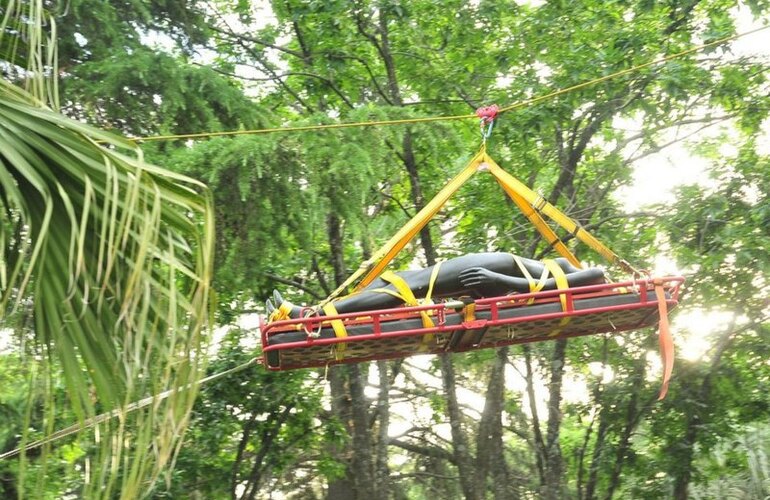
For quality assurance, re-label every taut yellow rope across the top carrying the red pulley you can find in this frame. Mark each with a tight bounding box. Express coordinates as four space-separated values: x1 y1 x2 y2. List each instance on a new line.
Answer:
115 25 770 142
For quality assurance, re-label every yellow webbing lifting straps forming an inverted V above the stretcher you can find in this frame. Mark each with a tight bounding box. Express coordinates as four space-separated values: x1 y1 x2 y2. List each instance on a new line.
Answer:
321 145 641 307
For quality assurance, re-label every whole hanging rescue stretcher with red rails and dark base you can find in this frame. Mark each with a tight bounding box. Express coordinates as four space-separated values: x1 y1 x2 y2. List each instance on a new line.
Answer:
260 277 684 370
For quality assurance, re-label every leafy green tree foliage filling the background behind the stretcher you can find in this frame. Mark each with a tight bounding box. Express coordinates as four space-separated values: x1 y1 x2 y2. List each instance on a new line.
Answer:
6 0 770 498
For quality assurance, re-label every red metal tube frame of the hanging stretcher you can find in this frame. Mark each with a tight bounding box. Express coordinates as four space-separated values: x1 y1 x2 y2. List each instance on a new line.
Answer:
260 276 684 371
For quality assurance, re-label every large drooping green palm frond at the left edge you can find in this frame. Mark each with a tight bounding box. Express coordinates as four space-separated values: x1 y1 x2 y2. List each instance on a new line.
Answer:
0 12 213 498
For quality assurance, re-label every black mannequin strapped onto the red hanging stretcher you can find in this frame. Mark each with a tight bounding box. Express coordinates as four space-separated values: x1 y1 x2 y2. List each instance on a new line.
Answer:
265 252 605 319
